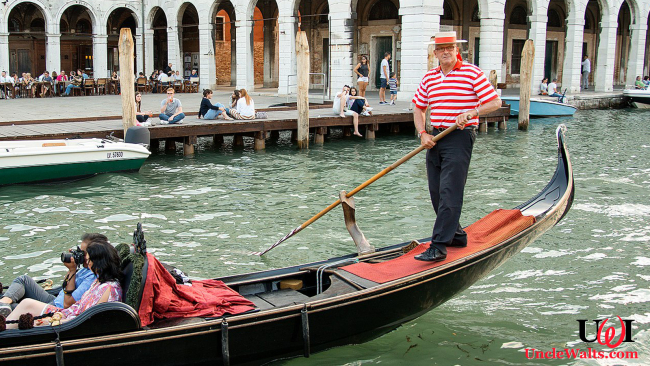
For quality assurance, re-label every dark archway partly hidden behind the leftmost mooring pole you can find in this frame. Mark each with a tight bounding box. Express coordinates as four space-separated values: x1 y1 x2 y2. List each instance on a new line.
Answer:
106 8 137 74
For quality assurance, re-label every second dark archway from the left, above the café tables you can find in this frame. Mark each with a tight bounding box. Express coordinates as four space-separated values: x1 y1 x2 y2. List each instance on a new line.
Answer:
56 5 94 75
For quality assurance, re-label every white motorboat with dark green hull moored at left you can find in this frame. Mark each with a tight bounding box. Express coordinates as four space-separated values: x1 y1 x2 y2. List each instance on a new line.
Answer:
0 139 151 185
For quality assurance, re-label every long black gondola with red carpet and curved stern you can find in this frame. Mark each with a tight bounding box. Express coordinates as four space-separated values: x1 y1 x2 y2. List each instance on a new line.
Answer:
0 126 574 366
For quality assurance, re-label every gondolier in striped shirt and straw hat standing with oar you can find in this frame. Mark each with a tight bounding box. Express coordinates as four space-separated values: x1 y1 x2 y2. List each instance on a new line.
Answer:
413 32 501 261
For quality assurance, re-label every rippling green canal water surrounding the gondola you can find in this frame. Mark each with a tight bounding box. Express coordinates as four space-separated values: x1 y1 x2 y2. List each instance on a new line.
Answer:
0 110 650 365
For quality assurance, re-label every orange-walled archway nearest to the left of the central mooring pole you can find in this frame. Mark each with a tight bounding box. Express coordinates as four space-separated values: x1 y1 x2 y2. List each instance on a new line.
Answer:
252 0 279 88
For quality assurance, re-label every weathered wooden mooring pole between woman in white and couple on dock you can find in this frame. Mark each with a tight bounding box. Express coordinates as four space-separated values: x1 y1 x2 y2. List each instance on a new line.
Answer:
296 31 309 149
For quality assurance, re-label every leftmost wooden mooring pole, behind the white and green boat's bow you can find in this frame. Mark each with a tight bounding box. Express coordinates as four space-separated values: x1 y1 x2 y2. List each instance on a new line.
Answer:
118 28 136 136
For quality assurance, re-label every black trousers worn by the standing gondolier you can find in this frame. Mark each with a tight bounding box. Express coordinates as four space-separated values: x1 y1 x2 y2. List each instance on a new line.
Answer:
427 128 476 254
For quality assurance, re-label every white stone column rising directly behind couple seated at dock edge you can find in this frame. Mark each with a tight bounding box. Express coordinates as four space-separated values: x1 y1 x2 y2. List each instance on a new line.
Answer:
329 8 355 95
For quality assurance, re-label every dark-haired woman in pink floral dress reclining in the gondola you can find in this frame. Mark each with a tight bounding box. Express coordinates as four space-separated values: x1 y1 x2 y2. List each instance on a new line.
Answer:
7 240 122 329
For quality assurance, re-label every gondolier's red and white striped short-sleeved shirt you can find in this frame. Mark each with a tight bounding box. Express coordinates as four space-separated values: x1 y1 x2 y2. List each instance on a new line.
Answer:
413 61 498 128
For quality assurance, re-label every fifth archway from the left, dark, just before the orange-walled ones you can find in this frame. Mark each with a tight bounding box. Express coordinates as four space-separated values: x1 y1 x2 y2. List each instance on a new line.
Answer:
178 3 201 76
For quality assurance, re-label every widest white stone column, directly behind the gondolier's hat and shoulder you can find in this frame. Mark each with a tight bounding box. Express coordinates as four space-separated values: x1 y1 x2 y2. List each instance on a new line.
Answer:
393 0 443 94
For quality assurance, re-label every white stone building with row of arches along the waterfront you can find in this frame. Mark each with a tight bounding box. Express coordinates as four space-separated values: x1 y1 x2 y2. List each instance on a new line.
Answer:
0 0 650 94
